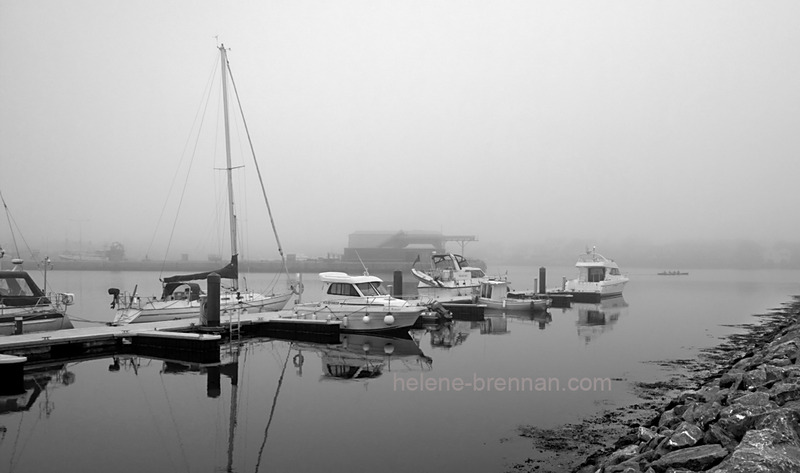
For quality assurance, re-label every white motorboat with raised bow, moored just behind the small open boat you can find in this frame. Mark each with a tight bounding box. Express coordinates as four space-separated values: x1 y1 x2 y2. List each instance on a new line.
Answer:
411 253 489 303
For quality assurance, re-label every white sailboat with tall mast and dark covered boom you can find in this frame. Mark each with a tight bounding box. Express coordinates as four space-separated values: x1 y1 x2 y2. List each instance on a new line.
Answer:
108 44 299 325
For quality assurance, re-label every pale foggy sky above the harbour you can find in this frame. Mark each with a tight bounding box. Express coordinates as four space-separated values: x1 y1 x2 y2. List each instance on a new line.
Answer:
0 0 800 258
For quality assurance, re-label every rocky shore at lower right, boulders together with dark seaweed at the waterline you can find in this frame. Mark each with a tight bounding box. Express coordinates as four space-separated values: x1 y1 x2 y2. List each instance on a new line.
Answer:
512 297 800 473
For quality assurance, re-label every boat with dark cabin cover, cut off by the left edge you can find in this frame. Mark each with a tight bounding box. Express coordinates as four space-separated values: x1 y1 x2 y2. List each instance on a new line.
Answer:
0 258 75 335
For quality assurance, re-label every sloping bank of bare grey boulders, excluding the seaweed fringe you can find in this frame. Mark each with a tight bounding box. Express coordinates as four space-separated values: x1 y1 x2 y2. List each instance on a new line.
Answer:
573 298 800 473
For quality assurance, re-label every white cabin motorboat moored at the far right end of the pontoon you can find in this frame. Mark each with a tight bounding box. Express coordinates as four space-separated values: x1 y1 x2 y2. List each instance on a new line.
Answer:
548 247 628 302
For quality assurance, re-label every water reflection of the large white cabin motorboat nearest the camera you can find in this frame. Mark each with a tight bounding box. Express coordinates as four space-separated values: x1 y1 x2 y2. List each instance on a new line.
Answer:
292 333 433 381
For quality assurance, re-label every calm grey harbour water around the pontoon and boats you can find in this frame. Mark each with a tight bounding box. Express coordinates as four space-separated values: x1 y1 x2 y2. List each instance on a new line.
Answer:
0 266 800 473
